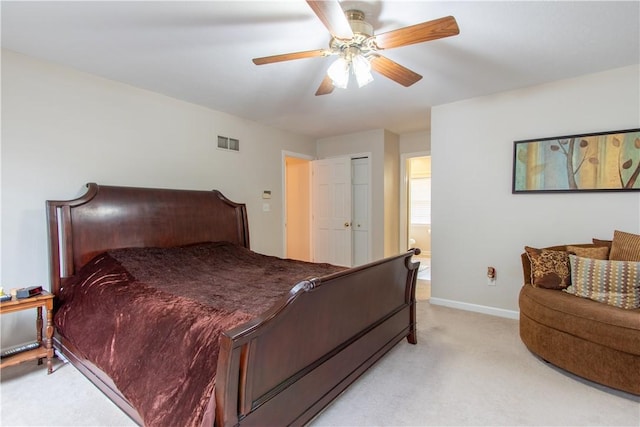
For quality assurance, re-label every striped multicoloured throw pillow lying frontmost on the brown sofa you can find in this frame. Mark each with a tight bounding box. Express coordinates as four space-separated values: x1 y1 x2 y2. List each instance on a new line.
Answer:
563 254 640 310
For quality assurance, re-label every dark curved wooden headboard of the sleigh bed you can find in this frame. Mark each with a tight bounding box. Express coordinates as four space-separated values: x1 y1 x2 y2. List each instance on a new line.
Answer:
47 183 249 294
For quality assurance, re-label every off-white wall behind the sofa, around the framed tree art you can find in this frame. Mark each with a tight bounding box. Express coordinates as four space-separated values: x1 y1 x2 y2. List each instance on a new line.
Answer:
431 66 640 314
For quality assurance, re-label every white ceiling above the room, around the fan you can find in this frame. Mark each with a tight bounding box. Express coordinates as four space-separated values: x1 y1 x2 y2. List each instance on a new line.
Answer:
1 0 640 138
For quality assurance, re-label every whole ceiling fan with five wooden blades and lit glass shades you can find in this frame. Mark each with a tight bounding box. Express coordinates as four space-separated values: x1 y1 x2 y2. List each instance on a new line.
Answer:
253 0 460 95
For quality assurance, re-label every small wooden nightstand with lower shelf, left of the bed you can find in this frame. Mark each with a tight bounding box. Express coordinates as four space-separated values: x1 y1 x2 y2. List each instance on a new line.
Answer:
0 291 53 374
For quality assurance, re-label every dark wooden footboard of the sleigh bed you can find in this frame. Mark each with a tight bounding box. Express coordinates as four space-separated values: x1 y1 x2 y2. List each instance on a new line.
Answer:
216 250 418 426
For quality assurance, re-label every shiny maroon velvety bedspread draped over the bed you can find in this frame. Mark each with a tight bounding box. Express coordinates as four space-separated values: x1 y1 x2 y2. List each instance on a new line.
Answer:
55 242 344 426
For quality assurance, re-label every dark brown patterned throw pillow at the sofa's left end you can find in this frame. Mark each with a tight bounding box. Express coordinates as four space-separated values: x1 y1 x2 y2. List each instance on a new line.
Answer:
524 246 571 289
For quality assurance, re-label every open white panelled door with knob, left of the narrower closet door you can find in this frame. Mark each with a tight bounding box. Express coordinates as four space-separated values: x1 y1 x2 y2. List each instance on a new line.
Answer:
312 157 352 267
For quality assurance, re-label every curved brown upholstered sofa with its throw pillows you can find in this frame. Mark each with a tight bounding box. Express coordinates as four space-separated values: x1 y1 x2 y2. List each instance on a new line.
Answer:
519 231 640 395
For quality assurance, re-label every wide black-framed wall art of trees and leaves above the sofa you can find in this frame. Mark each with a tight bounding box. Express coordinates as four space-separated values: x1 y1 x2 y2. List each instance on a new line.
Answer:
512 129 640 194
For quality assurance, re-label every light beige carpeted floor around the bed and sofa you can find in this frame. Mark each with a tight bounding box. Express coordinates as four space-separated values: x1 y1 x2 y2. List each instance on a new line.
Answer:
0 302 640 426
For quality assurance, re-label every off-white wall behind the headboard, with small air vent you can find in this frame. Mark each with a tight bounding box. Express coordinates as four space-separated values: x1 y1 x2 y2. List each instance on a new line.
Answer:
0 50 315 346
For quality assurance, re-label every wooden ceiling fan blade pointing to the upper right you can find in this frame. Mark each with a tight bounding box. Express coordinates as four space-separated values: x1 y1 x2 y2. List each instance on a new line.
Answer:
375 16 460 49
